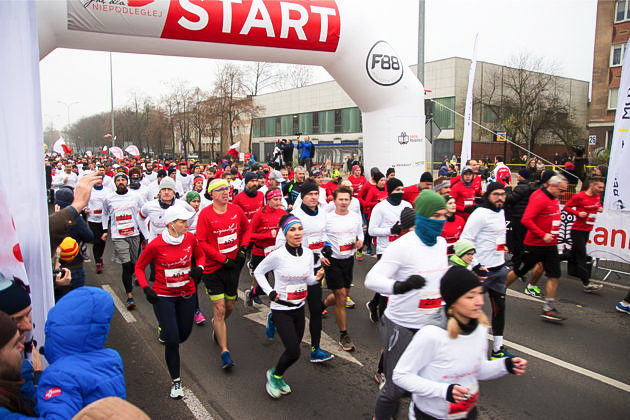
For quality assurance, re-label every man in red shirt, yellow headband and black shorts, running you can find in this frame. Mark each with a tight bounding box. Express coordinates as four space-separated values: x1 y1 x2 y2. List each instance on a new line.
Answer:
197 179 251 369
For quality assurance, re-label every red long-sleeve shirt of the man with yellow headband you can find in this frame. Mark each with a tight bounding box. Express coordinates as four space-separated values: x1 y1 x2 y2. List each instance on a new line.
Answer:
197 204 251 273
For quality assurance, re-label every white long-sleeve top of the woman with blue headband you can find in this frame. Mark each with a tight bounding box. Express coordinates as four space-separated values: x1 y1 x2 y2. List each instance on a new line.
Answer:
254 245 317 311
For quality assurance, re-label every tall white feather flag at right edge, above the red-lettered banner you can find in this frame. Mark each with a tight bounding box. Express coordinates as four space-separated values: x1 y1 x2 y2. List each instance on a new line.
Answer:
604 40 630 211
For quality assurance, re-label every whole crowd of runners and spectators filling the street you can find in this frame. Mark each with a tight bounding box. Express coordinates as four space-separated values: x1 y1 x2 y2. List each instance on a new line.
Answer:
0 148 630 419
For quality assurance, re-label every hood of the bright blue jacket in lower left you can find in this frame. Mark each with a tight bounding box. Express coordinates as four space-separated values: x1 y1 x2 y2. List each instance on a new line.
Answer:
44 286 114 363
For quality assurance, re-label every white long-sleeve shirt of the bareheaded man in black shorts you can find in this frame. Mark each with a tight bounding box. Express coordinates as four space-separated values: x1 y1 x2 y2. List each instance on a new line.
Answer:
326 212 363 260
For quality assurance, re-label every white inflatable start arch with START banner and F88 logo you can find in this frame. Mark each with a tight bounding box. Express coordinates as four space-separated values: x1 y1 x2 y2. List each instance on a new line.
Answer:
0 0 425 340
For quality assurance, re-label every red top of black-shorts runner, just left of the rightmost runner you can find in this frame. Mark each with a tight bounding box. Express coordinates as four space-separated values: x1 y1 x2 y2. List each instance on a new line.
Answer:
521 188 561 246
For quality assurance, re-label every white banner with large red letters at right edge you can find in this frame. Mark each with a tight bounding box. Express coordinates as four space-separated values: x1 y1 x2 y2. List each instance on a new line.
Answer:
586 210 630 263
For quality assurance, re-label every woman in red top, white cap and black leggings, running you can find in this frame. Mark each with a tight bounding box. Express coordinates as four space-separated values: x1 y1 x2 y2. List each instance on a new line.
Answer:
135 206 205 398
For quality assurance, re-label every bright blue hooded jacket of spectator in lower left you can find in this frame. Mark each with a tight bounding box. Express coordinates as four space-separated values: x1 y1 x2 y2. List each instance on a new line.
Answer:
37 286 125 419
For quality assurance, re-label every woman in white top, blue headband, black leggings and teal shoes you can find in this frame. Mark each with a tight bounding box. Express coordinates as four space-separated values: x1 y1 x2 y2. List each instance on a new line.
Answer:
254 215 324 398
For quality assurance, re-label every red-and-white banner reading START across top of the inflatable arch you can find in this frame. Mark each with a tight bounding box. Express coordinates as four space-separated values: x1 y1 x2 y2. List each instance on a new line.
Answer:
67 0 341 52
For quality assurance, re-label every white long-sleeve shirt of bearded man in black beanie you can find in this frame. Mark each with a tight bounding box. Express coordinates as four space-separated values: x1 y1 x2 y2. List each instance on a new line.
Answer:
460 207 505 268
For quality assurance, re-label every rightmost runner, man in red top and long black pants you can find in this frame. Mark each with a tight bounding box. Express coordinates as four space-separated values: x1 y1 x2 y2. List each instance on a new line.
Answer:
564 177 606 293
